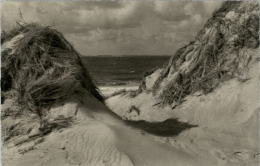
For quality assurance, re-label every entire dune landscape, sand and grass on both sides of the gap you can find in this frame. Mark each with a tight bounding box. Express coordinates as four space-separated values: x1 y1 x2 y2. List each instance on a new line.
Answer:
1 2 260 166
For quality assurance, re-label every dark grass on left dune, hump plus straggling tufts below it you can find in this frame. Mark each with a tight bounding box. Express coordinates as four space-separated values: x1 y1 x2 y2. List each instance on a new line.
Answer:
1 24 103 145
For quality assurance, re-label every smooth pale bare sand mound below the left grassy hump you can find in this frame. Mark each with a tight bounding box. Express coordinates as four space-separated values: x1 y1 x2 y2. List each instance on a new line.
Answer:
4 92 213 166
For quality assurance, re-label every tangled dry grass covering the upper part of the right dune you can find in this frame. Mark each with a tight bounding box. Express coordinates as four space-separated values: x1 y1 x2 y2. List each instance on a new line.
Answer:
141 1 259 105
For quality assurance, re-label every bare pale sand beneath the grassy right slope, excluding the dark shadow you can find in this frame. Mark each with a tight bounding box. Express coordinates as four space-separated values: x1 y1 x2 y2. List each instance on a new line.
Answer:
106 58 260 166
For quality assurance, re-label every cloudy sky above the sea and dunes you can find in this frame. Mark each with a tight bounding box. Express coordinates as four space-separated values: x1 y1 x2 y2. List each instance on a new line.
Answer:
1 0 221 56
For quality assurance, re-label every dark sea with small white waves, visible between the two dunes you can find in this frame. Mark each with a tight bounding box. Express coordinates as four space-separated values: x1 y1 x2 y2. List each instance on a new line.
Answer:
81 55 170 87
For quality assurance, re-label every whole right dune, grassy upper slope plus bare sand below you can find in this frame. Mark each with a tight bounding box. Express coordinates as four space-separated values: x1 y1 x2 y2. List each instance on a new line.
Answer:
106 1 260 166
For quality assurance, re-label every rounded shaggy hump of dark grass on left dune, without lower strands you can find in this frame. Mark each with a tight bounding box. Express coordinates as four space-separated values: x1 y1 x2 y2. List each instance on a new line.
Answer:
1 24 103 114
